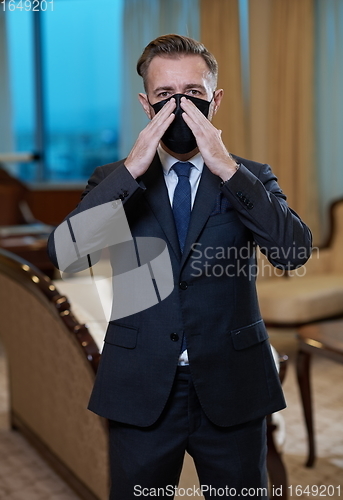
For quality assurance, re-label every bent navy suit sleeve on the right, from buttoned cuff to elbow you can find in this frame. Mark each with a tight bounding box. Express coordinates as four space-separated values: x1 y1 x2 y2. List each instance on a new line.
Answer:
222 163 312 270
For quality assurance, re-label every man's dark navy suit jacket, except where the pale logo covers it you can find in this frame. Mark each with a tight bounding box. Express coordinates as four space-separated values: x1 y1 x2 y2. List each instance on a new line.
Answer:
49 155 311 426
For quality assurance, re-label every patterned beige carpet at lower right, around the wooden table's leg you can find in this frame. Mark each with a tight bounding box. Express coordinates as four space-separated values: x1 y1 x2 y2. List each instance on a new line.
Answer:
271 332 343 500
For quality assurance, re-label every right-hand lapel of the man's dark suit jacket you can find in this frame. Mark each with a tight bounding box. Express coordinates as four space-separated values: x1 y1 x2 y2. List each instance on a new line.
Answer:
181 165 221 267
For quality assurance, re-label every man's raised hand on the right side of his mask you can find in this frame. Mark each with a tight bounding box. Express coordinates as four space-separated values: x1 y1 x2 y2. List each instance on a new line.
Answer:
180 97 237 181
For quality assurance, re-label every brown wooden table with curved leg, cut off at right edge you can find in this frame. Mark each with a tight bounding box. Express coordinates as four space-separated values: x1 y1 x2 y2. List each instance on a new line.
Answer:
297 319 343 467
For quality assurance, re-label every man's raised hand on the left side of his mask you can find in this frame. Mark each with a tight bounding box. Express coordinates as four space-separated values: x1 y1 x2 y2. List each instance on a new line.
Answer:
125 98 176 179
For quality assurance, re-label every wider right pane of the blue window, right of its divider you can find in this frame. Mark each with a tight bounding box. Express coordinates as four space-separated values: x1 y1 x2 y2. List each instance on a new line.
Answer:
42 0 122 179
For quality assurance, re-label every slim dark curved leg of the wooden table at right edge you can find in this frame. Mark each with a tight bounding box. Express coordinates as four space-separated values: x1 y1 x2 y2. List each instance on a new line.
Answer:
297 349 316 467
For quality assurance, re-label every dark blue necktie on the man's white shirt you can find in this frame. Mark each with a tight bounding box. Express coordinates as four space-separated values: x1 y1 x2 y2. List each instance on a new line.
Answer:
173 161 193 252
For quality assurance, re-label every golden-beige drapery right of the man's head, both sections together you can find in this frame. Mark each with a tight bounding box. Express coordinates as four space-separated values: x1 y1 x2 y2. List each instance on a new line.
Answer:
200 0 319 241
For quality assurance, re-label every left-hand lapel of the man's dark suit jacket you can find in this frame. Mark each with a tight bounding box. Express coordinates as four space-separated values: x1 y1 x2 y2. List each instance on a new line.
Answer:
140 154 181 260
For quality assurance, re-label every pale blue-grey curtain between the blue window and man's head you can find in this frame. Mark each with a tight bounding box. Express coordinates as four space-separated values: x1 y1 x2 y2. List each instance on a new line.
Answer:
120 0 199 158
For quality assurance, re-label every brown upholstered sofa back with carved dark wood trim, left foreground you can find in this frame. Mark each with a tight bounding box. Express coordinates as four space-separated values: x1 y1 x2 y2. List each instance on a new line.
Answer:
0 250 109 500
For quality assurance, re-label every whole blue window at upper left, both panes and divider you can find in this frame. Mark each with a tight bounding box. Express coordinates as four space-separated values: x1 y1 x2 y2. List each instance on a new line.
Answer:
6 0 122 181
